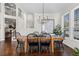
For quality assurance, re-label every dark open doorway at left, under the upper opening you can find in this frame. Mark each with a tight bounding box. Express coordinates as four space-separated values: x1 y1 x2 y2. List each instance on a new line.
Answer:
5 18 16 42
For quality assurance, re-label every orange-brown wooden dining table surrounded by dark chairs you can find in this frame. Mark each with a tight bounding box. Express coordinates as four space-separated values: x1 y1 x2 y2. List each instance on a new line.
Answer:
17 36 63 53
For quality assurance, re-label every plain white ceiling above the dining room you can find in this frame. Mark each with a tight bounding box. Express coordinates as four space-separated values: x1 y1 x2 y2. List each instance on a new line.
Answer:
17 3 77 13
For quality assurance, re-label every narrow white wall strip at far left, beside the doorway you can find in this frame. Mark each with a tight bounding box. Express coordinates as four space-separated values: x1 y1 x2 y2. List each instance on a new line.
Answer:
0 3 5 41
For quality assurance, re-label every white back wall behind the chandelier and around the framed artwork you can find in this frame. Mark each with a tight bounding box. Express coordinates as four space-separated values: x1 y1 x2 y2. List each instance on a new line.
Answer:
22 13 61 33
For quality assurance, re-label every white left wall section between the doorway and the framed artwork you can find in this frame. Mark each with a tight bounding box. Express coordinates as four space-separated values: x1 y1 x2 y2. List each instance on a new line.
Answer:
16 13 26 35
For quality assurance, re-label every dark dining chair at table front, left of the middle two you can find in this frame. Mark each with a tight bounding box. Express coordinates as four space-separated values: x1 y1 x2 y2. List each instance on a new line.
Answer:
27 33 39 53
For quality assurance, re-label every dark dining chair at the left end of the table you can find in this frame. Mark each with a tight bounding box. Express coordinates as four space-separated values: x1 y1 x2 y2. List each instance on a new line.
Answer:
16 32 24 53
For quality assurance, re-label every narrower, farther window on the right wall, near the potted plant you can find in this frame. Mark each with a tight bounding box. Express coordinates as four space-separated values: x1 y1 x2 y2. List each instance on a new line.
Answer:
64 13 69 37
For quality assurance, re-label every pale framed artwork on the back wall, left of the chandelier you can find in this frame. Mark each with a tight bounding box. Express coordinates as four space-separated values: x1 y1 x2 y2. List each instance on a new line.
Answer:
26 14 34 28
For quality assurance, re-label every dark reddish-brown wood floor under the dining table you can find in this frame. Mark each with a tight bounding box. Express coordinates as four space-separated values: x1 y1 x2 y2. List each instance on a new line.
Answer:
0 41 73 56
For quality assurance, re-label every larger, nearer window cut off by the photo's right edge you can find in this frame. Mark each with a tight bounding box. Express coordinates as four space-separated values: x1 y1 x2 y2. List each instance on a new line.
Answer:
74 8 79 40
